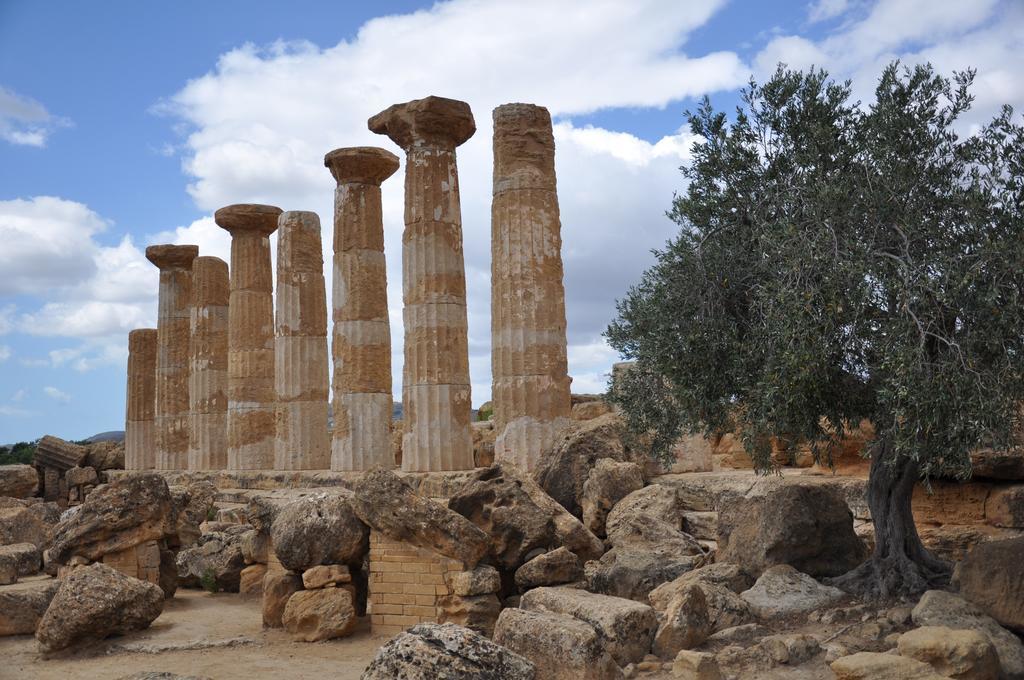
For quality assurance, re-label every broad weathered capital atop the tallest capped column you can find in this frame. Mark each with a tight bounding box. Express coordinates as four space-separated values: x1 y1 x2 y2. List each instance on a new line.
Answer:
367 96 476 151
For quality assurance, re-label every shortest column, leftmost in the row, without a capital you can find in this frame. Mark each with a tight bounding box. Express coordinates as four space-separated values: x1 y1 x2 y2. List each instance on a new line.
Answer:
125 328 157 470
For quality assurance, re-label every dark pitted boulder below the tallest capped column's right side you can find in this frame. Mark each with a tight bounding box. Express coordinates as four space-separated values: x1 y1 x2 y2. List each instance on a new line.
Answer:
449 464 556 569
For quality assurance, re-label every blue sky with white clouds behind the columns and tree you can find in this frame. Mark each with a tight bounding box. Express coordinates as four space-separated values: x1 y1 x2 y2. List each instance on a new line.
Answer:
0 0 1024 443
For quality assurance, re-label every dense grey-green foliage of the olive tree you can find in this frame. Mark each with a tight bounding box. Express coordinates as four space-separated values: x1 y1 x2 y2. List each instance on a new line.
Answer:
606 63 1024 477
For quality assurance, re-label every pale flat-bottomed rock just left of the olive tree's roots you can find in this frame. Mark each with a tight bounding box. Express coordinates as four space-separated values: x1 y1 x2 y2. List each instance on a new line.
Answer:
739 564 846 619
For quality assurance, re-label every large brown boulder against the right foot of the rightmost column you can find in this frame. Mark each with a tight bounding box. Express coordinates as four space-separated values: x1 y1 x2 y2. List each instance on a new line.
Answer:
534 414 630 517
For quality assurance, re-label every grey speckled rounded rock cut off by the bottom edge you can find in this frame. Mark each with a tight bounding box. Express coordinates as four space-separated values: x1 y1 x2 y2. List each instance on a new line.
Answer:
361 624 541 680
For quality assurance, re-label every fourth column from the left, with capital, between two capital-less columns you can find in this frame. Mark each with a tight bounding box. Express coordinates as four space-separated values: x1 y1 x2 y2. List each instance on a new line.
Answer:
213 204 281 470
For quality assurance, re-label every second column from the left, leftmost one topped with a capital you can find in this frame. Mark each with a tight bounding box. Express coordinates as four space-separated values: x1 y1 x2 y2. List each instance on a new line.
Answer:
145 245 199 470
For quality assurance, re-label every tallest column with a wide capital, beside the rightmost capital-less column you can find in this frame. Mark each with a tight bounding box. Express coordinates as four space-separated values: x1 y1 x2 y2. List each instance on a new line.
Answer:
369 97 476 471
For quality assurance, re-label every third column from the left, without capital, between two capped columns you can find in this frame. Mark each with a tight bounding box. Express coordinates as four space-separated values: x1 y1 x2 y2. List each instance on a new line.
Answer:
188 257 229 470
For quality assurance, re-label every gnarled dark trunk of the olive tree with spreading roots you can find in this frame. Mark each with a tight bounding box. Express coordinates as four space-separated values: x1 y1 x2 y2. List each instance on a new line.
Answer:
831 440 952 599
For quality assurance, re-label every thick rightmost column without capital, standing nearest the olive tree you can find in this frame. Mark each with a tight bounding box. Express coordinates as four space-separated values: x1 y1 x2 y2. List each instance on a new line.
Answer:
490 103 572 470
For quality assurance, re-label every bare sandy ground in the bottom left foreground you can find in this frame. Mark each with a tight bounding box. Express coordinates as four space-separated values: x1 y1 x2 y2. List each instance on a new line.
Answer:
0 590 387 680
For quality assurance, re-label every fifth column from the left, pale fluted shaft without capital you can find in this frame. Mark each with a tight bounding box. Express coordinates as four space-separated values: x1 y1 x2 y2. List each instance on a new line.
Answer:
273 210 331 470
